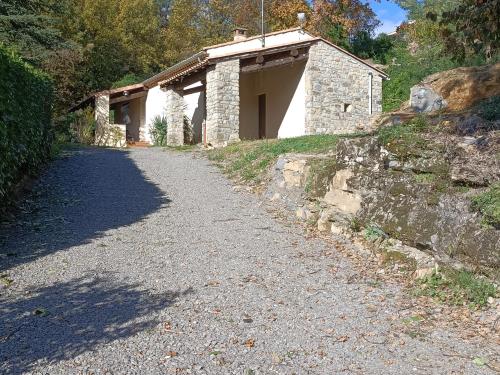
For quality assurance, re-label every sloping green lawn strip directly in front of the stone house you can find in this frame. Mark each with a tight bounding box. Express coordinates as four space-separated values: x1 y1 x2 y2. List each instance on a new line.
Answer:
209 135 359 183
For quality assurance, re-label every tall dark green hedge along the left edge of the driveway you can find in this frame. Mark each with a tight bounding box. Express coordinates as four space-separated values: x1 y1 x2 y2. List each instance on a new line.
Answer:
0 44 53 212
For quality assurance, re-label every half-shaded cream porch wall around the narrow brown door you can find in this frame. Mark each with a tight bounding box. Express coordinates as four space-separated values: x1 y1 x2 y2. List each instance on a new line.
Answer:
240 62 306 139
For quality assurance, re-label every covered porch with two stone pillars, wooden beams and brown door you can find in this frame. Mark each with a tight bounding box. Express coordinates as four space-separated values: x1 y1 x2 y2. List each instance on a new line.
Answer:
160 42 311 147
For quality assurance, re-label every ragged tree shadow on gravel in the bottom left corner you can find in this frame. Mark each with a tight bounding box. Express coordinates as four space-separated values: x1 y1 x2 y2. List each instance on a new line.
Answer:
0 274 193 374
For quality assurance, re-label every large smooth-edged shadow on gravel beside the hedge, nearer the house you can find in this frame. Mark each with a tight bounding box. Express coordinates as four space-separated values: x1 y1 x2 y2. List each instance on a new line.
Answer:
0 148 169 271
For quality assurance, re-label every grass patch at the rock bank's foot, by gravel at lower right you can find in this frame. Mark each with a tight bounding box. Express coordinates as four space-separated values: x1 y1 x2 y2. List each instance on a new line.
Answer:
416 268 498 308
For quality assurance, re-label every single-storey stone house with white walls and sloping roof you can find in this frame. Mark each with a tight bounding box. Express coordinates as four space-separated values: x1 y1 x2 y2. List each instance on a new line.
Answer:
71 28 388 147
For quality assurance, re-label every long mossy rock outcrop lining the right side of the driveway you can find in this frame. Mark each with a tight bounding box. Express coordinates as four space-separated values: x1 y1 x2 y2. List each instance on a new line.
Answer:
267 136 500 268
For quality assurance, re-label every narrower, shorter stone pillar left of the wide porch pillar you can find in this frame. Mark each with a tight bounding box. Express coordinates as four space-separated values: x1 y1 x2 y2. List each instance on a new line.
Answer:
165 87 184 146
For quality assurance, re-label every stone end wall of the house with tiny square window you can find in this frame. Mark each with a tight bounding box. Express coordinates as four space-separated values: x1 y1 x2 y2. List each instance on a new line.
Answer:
305 41 382 134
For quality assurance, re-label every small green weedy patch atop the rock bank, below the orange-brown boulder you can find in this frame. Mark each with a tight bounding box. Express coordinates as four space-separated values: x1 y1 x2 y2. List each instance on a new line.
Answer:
377 116 430 159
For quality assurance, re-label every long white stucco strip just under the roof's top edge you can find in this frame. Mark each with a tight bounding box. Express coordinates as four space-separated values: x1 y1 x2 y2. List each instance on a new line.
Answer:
207 30 314 58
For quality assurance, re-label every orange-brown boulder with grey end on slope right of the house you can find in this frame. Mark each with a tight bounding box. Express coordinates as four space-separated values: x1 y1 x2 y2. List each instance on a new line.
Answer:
410 63 500 112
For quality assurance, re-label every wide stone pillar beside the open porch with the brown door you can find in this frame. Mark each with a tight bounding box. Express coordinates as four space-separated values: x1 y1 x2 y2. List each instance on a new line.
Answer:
206 60 240 147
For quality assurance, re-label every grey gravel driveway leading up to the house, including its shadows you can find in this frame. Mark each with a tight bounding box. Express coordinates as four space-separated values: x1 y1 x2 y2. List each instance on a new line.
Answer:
0 149 495 375
